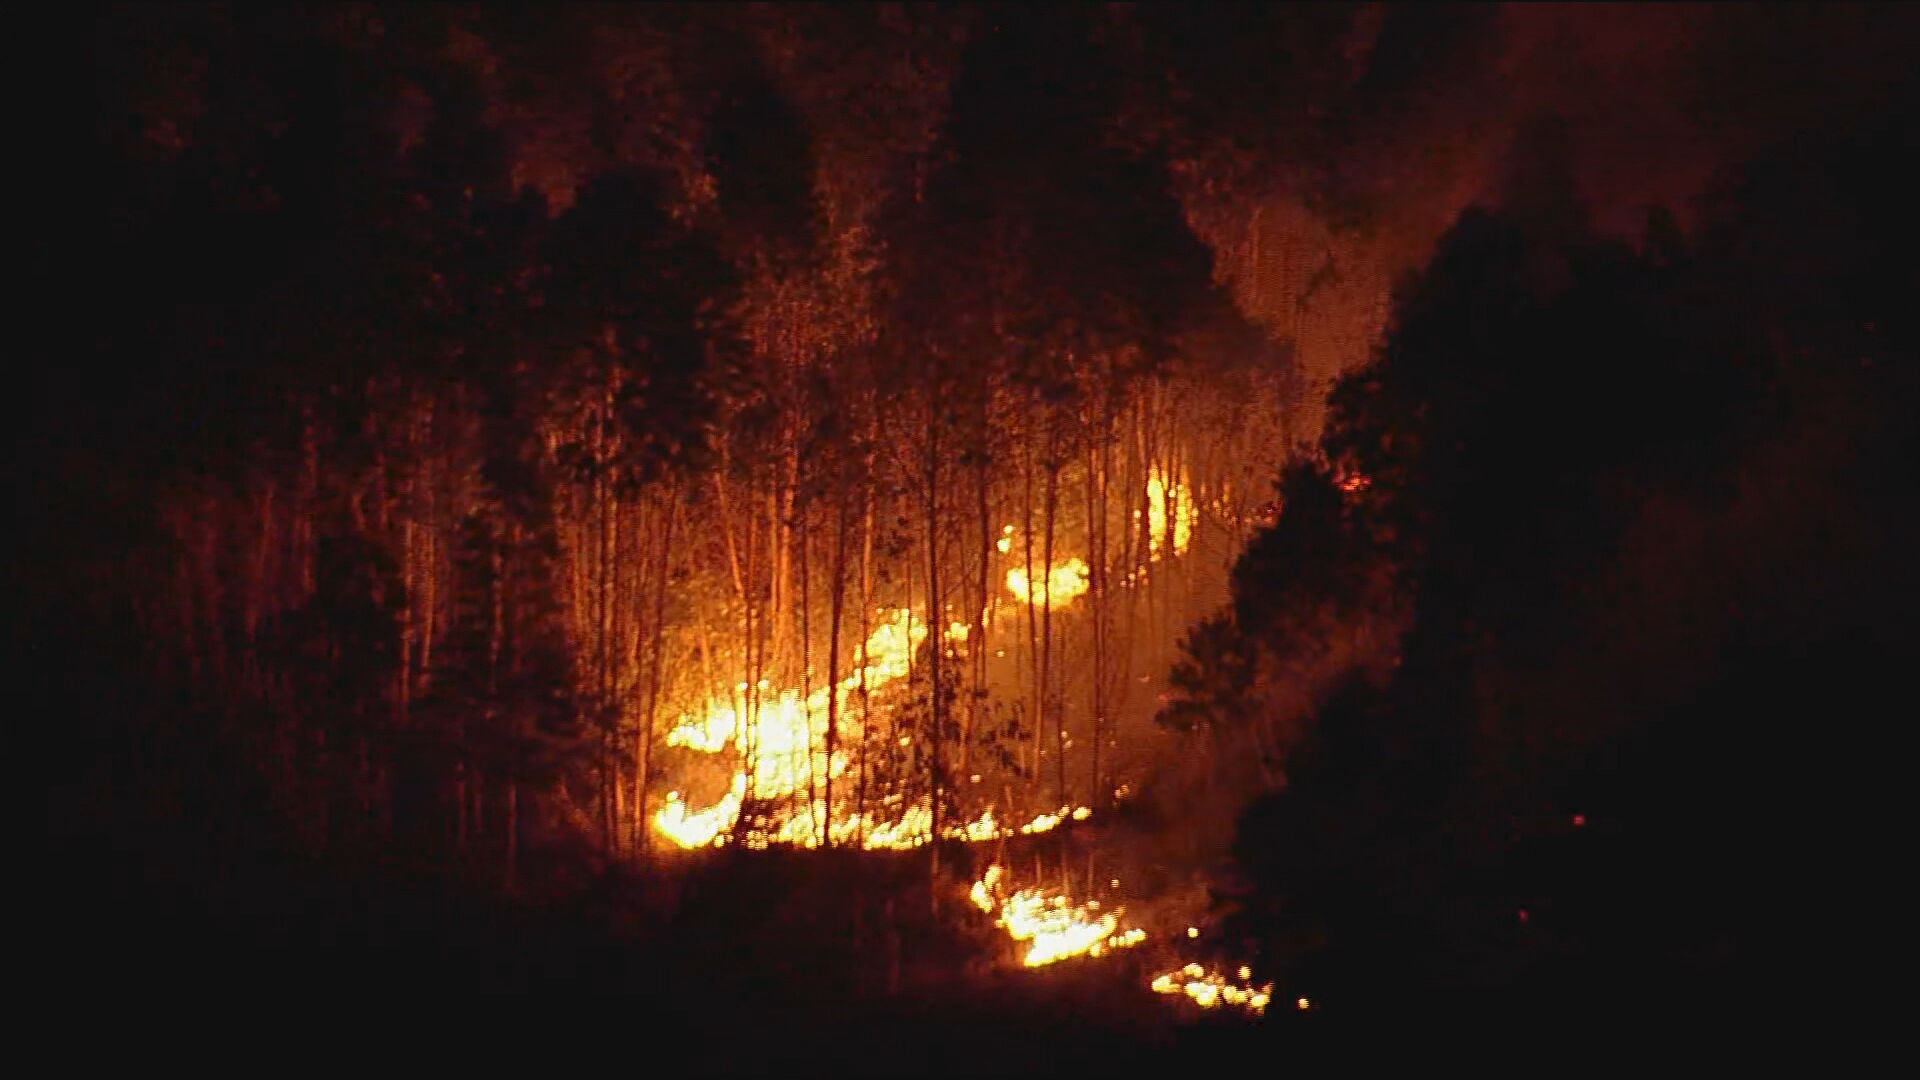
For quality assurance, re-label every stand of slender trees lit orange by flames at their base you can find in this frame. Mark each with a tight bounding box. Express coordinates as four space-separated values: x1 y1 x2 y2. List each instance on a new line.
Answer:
74 2 1298 886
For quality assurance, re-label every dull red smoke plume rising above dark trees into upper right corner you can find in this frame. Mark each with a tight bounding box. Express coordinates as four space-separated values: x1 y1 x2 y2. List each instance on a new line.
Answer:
1169 4 1916 432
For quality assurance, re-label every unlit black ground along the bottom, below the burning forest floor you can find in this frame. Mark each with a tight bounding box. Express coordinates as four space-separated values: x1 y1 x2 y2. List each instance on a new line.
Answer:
48 791 1791 1076
